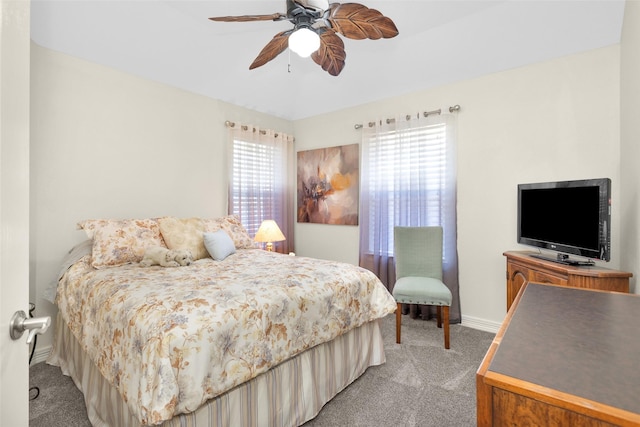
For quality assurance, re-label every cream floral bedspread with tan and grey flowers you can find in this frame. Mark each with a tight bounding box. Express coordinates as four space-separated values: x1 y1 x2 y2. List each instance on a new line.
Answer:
57 249 396 424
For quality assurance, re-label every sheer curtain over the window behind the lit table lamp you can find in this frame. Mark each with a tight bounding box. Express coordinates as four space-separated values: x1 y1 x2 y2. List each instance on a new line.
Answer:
228 123 294 253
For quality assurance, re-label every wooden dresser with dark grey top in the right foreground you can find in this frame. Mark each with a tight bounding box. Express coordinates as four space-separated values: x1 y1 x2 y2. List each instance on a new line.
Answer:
476 282 640 427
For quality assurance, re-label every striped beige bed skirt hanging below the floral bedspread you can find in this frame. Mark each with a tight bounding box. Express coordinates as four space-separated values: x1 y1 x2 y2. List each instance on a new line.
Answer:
47 316 385 427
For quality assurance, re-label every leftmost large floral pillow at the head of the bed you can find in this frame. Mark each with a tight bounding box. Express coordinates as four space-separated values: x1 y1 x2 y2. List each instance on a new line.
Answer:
78 219 166 269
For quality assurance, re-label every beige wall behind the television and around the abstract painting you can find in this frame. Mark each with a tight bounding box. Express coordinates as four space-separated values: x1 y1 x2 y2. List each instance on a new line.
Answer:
295 45 624 329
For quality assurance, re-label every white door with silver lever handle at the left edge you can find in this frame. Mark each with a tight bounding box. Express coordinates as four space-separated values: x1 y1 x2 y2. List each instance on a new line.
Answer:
0 0 30 427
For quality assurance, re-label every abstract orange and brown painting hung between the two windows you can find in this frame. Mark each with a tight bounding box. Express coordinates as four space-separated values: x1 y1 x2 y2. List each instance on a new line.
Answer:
297 144 360 225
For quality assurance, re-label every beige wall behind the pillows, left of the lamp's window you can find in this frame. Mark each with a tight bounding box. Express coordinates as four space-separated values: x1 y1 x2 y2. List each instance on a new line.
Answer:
30 44 293 349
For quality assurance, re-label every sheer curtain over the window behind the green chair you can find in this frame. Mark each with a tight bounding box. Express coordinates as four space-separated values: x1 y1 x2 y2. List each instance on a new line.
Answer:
360 114 461 322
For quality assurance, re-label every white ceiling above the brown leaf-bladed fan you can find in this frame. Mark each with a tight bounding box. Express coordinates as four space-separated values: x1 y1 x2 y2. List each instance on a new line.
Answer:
31 0 624 120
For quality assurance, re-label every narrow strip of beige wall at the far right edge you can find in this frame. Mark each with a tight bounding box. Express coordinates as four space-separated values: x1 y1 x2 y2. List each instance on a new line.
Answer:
620 1 640 294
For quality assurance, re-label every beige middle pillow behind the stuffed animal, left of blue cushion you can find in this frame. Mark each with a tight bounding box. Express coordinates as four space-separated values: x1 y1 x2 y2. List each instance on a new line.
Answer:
158 217 209 260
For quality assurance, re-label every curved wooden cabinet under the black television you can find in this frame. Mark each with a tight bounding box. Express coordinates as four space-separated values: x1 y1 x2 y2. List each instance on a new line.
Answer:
503 251 633 310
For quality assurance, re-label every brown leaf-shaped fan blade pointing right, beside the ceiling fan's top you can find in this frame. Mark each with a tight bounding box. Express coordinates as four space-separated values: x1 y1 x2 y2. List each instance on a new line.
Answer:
327 3 398 40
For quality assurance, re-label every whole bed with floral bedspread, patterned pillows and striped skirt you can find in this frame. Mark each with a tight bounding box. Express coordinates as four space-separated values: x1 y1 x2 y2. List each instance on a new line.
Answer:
47 216 396 426
